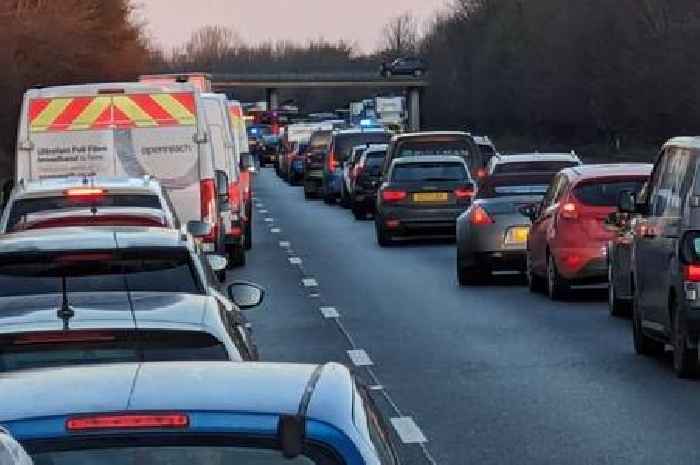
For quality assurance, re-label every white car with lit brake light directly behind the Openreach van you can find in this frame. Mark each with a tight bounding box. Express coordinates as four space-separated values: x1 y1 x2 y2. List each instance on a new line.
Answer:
0 176 181 234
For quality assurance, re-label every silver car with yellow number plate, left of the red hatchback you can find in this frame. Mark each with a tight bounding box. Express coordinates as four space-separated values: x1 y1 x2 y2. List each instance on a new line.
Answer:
457 173 555 285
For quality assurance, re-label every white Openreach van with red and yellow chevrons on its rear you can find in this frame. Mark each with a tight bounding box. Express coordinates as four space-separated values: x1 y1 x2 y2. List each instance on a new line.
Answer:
15 83 231 251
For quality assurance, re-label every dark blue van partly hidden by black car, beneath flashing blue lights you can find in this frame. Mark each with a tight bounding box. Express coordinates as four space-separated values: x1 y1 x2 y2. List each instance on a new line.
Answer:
322 128 391 203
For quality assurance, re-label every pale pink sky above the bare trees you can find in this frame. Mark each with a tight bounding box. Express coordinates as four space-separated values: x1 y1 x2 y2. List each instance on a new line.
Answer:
136 0 448 52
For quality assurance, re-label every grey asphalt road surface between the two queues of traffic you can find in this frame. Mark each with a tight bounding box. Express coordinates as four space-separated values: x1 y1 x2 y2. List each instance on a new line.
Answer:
234 169 700 465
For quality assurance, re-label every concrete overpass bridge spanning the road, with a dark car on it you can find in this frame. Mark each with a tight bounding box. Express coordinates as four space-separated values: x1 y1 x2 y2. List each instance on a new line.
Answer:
212 73 429 131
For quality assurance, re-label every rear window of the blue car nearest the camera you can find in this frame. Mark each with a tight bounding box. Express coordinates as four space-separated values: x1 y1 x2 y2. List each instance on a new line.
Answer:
27 440 344 465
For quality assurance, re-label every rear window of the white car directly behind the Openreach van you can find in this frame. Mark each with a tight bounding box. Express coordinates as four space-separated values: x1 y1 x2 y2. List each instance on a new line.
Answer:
7 194 162 231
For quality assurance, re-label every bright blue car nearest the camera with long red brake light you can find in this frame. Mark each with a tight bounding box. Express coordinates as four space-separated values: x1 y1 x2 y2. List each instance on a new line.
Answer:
0 362 398 465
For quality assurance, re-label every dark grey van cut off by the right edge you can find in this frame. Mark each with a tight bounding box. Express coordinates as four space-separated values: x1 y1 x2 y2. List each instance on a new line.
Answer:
619 137 700 378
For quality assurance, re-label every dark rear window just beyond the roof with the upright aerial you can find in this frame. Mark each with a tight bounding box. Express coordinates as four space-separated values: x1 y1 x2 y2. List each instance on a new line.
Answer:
0 247 204 297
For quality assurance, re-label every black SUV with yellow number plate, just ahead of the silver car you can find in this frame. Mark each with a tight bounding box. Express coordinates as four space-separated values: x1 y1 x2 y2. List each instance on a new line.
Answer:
374 156 474 247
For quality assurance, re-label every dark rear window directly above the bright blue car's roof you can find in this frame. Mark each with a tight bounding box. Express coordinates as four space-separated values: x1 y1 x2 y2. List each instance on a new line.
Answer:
0 328 229 373
